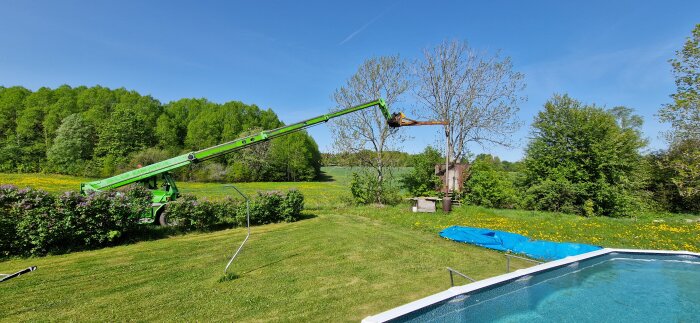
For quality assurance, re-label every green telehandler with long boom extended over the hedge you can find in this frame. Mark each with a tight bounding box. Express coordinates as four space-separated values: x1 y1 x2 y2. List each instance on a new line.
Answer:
80 99 412 225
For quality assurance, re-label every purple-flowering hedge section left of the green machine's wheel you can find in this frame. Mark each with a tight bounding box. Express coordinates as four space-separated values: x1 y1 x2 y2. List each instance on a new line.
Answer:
0 185 151 256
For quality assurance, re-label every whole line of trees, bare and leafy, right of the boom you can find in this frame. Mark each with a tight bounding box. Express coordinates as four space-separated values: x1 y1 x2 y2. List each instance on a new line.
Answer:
346 24 700 217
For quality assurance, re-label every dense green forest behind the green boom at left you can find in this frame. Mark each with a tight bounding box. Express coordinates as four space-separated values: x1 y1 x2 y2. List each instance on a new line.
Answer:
0 85 321 181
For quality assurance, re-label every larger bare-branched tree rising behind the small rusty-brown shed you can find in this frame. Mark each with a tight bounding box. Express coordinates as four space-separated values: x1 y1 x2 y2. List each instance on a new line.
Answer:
416 41 525 189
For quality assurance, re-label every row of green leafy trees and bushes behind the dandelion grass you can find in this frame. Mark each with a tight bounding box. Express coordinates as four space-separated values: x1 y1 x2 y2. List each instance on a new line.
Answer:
401 95 700 217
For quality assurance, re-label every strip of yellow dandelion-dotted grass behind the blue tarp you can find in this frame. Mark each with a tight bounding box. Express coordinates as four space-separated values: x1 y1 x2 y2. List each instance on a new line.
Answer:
346 206 700 252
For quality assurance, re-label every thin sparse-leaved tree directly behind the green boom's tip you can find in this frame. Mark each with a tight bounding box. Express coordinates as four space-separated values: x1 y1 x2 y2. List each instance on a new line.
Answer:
330 55 409 203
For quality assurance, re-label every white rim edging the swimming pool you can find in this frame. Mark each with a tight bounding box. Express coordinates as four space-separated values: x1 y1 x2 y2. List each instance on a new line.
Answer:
362 248 700 323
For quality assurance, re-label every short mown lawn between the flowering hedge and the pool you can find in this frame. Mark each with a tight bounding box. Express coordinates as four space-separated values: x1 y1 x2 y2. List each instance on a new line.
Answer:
0 211 529 322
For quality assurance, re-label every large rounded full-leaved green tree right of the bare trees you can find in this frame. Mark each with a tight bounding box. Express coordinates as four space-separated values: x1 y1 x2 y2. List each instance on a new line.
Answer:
524 95 646 216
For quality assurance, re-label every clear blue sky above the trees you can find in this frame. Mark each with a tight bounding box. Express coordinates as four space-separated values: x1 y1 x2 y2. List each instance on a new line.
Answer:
0 0 700 160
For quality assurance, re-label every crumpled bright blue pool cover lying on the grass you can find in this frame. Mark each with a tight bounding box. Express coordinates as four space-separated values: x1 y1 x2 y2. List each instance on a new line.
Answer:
440 226 601 260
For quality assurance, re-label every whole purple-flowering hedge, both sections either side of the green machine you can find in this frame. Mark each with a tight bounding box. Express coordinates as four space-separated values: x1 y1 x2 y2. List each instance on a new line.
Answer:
0 185 304 258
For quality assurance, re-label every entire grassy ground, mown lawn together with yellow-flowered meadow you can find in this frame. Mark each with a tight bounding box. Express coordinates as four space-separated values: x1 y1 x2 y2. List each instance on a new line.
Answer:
0 168 700 322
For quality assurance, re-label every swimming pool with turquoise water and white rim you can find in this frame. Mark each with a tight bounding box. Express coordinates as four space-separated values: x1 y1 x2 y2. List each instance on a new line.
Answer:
363 249 700 322
